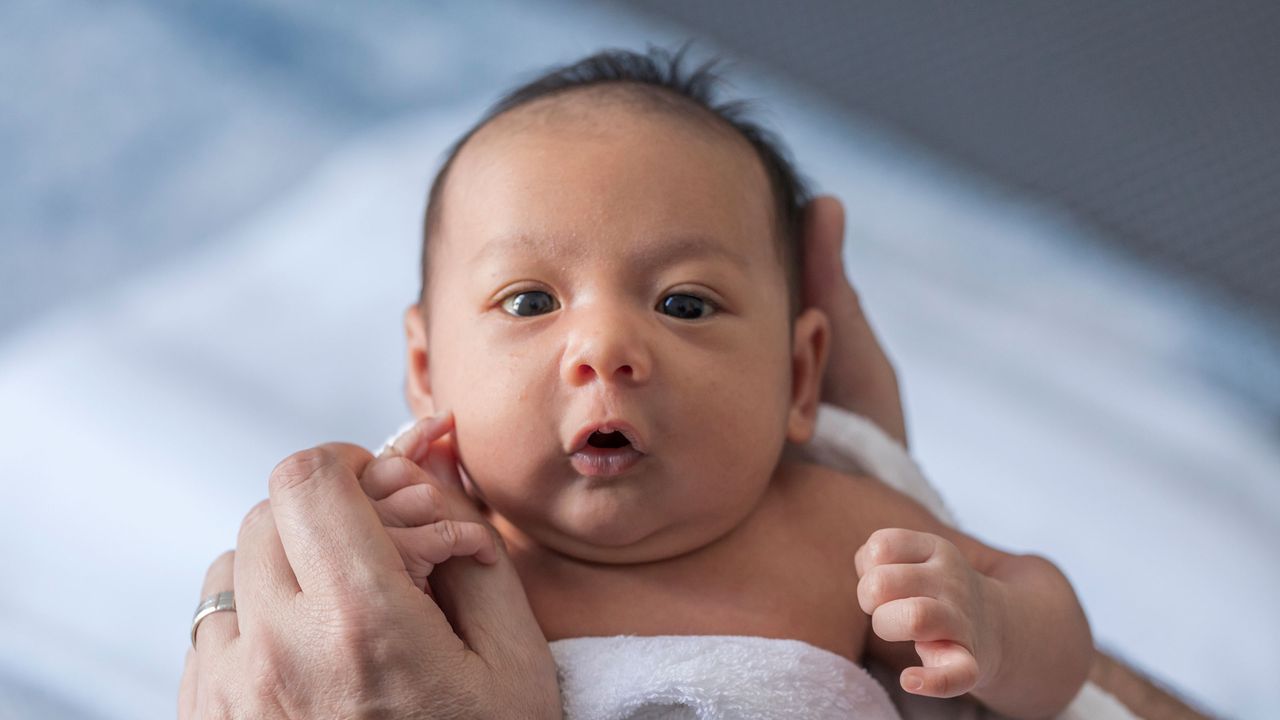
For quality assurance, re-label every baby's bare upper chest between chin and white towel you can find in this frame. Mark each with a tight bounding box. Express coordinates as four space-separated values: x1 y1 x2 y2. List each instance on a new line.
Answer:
524 491 869 662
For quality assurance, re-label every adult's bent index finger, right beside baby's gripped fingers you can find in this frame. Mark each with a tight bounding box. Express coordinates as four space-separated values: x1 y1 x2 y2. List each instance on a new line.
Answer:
269 443 403 596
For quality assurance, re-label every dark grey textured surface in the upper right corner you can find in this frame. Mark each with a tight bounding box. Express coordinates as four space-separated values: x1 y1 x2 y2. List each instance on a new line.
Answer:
614 0 1280 331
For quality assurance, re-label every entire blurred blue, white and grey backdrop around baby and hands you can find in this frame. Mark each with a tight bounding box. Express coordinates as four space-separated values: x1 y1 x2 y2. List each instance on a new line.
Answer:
0 0 1280 719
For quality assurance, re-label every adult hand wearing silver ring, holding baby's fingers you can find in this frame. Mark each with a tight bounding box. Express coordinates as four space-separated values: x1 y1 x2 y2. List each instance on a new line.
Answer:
178 445 561 720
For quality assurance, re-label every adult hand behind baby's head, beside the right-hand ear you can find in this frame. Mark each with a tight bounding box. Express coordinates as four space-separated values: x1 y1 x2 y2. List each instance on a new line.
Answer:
804 195 906 447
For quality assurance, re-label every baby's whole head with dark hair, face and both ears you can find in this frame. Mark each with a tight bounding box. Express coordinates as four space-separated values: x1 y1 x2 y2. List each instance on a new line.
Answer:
404 51 827 562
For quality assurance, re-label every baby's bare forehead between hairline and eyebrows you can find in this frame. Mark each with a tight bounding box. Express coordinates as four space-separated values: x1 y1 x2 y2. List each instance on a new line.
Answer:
428 85 787 307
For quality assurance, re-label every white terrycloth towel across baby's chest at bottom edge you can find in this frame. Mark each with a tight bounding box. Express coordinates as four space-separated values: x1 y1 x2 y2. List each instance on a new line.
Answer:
550 635 900 720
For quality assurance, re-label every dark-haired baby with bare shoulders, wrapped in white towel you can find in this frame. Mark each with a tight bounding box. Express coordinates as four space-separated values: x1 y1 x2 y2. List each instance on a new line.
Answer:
361 51 1092 717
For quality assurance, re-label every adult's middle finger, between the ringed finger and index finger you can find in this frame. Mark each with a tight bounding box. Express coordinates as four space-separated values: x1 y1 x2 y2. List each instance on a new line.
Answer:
234 500 301 634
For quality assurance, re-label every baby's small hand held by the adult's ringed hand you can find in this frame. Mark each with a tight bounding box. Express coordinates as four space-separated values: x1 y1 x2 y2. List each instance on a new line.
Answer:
360 413 498 593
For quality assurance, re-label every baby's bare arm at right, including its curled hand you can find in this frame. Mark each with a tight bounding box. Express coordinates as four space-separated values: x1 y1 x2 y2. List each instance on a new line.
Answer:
855 483 1093 717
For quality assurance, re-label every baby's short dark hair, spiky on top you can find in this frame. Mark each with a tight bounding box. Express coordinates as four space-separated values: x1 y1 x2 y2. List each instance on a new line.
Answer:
419 44 809 319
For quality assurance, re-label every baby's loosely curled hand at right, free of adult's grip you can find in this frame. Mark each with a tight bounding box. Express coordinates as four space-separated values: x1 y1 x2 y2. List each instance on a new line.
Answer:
854 528 1000 697
